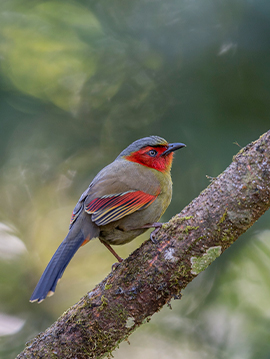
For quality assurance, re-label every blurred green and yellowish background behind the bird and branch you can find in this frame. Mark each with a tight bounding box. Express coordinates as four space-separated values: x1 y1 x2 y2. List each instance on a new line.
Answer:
0 0 270 359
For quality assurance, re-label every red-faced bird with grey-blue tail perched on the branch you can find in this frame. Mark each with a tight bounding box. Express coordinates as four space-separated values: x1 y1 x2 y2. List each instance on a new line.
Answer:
30 136 186 303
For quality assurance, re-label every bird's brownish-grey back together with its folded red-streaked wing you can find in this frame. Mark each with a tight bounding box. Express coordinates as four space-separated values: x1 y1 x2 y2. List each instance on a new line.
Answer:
70 160 160 228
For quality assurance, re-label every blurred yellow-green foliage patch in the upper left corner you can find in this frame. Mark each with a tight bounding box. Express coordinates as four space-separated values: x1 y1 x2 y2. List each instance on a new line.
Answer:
0 1 102 111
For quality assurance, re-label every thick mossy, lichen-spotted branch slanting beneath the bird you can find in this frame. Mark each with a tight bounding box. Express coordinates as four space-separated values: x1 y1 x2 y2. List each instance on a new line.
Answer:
17 131 270 358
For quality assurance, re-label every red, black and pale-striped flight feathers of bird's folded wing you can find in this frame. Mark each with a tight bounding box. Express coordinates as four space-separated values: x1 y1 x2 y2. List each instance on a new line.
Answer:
85 191 157 226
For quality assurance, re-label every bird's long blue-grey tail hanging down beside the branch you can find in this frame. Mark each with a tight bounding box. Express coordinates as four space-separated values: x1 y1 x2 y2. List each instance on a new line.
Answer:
30 230 85 303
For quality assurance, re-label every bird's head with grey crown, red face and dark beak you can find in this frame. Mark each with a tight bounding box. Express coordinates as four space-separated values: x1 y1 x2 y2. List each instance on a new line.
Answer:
117 136 186 172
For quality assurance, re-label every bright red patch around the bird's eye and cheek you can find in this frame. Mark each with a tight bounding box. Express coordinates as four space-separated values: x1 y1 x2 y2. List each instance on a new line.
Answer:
126 146 173 172
